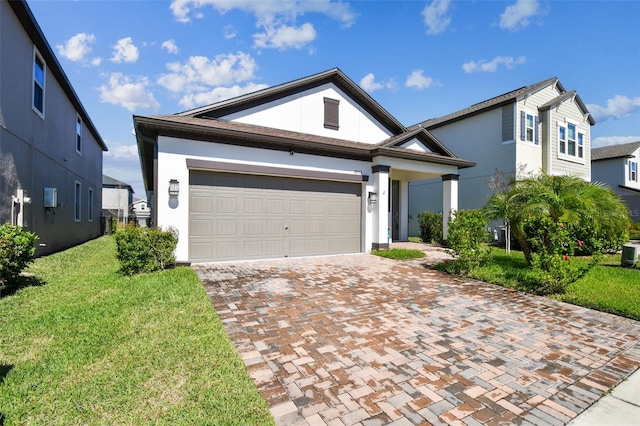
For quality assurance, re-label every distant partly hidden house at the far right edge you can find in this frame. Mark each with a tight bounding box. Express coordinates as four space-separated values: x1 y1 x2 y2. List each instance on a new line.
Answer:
591 141 640 222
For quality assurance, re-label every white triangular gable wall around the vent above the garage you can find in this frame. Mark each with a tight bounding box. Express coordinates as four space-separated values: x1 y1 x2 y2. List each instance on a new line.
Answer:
222 83 392 144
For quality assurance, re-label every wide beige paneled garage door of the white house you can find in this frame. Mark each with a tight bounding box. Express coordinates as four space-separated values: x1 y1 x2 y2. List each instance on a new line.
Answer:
189 170 362 262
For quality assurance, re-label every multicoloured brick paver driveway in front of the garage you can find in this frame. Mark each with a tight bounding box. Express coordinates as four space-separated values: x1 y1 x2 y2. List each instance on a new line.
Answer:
194 254 640 425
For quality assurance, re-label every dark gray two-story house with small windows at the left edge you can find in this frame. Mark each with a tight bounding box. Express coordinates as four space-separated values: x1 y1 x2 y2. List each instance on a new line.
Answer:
0 0 107 256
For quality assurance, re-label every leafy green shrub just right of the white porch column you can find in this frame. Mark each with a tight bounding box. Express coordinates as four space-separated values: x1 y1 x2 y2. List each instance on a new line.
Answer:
447 210 491 274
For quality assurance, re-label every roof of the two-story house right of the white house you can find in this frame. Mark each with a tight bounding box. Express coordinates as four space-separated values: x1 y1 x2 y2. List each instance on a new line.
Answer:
409 77 595 129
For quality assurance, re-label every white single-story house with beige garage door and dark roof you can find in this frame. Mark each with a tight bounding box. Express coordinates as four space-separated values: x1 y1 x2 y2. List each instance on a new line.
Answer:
134 69 473 262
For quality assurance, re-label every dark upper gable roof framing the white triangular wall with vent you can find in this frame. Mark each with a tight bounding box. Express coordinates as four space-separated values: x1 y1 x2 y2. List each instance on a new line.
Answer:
176 68 406 134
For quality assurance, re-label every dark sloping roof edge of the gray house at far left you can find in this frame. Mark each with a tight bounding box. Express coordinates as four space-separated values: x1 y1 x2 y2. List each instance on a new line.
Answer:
8 0 109 151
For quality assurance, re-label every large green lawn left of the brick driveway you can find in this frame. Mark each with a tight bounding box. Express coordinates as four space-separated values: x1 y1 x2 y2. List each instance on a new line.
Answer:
0 237 273 426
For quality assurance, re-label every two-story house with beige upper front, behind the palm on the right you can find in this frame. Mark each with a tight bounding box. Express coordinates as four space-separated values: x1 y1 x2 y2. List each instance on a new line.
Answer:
409 77 595 235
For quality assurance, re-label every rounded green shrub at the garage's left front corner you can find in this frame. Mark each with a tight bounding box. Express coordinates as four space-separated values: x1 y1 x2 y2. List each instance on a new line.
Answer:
115 225 178 275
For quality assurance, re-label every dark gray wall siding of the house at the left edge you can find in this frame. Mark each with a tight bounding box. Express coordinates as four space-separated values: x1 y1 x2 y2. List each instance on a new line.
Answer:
0 1 102 255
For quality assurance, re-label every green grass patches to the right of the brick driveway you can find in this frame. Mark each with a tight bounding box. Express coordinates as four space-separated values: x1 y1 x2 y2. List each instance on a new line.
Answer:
456 248 640 320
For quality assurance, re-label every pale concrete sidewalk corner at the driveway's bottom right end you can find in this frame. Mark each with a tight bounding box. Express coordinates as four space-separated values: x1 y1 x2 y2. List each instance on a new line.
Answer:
568 370 640 426
